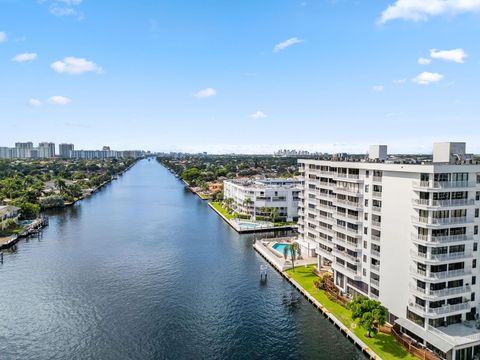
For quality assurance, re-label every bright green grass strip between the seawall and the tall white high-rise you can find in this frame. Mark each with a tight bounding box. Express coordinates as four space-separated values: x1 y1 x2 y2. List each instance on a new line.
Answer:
287 265 417 360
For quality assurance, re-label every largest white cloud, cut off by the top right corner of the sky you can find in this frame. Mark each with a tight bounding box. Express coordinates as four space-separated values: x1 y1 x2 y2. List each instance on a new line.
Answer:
380 0 480 24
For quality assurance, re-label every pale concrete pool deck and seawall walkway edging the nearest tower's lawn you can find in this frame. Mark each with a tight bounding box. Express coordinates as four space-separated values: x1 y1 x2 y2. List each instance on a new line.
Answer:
253 239 382 360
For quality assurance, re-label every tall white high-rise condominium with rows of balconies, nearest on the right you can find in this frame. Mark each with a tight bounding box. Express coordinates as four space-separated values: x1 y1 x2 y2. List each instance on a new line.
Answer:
299 143 480 360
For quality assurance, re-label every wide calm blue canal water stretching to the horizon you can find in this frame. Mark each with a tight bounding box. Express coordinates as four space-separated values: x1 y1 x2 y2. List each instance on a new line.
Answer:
0 160 363 360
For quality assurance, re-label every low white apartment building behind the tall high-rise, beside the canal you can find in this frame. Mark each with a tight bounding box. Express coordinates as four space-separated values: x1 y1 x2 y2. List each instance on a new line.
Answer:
223 179 302 221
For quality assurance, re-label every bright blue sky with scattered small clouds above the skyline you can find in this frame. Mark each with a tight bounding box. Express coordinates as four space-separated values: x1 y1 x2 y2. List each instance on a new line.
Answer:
0 0 480 153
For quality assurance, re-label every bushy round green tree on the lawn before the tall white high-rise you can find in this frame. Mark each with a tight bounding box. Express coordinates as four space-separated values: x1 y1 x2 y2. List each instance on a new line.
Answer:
348 296 388 337
